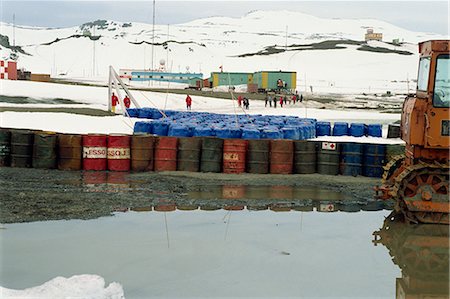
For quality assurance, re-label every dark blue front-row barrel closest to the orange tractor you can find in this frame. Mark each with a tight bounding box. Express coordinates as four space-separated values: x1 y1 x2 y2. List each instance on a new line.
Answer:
363 144 386 178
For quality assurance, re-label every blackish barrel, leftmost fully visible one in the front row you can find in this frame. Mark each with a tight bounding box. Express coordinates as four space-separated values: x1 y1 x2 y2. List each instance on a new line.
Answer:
11 130 34 167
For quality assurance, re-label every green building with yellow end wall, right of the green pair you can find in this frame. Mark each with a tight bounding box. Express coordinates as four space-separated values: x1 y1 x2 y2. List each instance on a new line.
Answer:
253 71 297 90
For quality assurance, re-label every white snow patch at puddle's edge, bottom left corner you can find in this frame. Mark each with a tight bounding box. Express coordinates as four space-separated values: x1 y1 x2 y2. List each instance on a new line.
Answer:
0 274 125 299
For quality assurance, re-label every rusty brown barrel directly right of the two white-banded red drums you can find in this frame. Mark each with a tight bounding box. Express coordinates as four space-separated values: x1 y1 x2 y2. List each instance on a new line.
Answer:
131 134 155 171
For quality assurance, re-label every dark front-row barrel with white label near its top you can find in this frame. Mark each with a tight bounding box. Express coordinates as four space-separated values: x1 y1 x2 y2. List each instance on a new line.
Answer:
317 142 341 175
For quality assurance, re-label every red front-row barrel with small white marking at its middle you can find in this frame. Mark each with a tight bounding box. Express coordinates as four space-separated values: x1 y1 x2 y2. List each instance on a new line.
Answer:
223 139 247 173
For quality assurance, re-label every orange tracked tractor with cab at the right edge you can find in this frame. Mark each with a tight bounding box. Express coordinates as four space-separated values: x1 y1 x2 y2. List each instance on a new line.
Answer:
376 40 450 224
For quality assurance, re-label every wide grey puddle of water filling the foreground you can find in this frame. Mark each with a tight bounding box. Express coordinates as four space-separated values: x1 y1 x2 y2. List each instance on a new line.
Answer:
0 210 448 298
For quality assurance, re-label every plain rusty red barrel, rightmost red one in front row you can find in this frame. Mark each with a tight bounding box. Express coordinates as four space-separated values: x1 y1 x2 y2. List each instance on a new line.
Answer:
270 139 294 174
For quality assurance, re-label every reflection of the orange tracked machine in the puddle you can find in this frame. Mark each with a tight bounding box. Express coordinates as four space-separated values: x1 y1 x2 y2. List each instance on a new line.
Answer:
374 213 449 298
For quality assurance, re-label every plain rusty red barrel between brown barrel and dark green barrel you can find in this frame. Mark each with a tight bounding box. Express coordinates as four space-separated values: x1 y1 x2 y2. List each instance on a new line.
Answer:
155 136 178 171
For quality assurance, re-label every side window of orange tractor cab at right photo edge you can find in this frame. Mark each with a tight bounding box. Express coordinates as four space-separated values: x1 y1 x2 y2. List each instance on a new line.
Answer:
433 54 450 108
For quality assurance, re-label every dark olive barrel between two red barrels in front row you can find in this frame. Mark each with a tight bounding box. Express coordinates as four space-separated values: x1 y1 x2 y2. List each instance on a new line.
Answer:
247 139 270 173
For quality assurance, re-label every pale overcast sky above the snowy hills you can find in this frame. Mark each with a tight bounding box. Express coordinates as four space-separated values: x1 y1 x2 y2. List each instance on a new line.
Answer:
0 0 449 35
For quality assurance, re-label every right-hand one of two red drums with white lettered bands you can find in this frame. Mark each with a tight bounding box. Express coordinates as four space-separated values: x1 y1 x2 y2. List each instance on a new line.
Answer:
108 134 130 171
